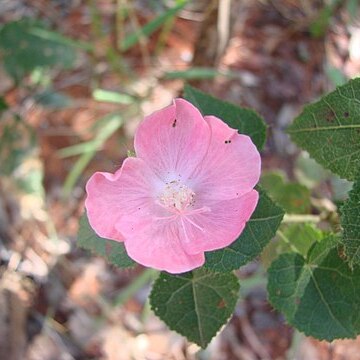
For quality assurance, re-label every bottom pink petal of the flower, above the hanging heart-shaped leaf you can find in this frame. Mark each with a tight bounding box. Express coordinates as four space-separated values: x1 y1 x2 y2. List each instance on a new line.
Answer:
125 220 205 274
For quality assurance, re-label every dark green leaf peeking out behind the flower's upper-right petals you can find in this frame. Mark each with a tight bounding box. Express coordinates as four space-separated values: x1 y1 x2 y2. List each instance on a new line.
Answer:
184 85 266 150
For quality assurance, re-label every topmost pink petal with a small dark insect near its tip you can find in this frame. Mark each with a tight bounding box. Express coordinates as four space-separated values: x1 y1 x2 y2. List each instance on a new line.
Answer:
135 99 210 181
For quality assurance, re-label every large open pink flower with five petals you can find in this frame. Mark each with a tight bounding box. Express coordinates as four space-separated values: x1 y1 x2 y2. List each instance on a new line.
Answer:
85 99 261 273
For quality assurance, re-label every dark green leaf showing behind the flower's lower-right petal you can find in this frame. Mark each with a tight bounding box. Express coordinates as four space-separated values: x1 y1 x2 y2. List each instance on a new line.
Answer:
205 190 284 272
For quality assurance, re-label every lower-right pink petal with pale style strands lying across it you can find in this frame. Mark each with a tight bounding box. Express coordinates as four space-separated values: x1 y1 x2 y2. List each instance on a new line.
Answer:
182 190 259 254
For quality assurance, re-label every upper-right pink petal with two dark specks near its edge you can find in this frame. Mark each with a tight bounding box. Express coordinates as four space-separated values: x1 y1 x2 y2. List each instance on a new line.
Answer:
193 116 261 200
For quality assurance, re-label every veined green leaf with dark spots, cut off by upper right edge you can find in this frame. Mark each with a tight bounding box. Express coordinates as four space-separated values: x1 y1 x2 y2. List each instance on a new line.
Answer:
288 78 360 180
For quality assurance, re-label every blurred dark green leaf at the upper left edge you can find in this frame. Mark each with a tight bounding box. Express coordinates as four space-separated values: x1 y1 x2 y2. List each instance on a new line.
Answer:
0 19 75 83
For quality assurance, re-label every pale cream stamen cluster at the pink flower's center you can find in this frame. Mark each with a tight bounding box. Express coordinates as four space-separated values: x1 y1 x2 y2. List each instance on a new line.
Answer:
159 180 195 212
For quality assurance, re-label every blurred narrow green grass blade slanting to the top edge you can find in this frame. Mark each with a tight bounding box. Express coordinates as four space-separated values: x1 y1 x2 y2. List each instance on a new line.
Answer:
120 1 187 51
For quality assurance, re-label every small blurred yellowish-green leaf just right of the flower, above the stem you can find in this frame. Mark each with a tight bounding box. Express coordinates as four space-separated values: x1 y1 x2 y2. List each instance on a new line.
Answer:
261 172 310 214
